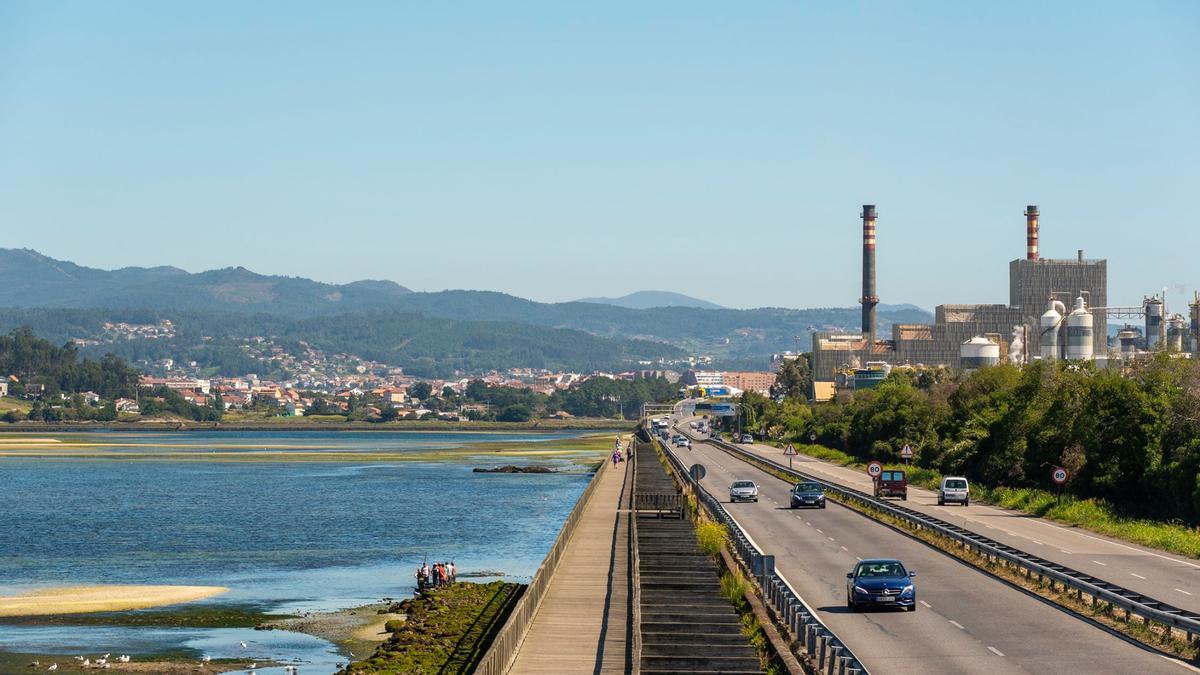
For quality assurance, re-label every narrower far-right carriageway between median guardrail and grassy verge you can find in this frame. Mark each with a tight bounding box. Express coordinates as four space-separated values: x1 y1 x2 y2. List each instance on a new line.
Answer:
679 420 1200 611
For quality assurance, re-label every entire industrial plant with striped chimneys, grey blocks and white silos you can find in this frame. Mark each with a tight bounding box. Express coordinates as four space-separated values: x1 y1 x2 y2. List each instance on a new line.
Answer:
812 204 1200 390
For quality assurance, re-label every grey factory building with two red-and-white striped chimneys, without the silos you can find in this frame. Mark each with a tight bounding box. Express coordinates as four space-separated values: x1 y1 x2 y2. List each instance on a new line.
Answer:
812 204 1108 381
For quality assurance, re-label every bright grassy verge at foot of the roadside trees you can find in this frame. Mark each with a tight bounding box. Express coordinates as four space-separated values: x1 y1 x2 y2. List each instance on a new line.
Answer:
796 444 1200 557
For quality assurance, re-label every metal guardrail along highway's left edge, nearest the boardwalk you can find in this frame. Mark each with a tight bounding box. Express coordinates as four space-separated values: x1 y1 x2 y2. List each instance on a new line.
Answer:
655 438 869 675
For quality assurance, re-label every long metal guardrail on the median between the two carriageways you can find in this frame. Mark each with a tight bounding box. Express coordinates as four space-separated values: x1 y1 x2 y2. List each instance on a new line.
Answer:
708 438 1200 641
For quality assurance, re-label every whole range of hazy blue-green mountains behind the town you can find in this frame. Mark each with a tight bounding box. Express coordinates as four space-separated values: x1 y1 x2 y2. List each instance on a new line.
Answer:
0 249 932 369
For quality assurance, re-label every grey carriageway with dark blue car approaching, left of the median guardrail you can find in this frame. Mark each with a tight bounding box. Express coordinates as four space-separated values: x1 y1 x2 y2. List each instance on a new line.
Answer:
671 422 1200 675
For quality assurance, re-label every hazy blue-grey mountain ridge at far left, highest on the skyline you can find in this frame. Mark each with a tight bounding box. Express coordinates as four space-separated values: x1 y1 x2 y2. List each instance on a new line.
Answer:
0 249 410 316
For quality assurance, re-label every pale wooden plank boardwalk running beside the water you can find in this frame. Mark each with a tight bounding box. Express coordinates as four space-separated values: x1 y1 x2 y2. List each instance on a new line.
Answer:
510 449 634 675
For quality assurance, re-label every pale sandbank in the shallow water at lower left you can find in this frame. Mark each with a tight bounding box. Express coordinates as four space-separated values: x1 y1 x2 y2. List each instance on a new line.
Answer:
0 585 229 616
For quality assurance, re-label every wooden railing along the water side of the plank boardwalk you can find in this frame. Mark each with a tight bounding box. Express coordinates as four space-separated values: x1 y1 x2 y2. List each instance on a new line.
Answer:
475 451 612 675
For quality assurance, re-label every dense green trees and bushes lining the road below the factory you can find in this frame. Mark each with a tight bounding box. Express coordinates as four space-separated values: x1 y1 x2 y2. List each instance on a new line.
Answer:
742 354 1200 557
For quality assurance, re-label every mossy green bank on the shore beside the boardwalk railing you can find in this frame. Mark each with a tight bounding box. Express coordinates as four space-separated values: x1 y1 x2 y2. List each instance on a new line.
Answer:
343 581 524 675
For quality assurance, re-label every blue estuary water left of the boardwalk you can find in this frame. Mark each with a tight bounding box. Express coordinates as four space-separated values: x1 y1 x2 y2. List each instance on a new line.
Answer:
0 432 595 673
